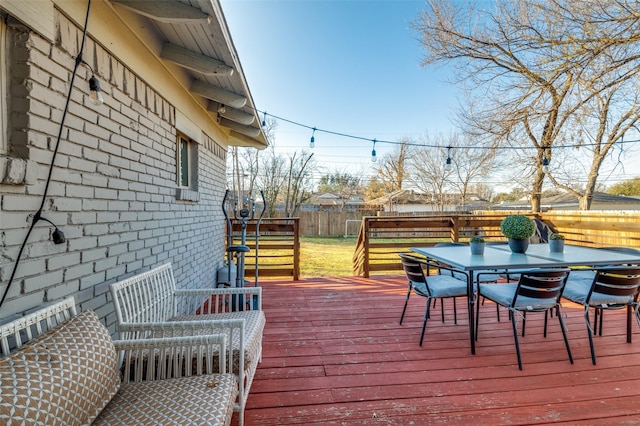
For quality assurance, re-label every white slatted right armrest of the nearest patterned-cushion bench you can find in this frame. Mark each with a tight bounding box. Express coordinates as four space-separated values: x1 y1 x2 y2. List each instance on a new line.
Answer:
113 334 227 383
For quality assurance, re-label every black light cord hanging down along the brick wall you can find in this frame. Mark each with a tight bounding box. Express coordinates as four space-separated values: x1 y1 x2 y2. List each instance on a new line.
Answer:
0 0 91 308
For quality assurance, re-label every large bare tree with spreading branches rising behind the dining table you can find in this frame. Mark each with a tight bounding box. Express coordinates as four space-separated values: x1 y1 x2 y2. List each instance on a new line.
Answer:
416 0 640 211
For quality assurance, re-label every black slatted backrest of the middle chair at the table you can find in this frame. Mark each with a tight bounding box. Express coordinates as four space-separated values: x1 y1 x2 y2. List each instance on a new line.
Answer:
512 268 570 308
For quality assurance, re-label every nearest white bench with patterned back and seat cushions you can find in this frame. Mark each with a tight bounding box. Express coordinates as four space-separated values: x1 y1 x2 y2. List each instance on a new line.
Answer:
0 298 238 426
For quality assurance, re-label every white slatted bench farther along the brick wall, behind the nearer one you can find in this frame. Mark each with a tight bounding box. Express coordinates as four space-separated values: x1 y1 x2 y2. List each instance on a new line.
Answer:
110 263 265 425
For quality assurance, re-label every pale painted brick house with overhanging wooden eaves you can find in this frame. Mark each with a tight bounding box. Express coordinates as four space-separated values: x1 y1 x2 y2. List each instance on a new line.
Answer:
0 0 267 332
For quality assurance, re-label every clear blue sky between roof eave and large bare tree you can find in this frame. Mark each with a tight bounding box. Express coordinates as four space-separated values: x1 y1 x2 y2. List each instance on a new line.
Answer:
221 0 457 181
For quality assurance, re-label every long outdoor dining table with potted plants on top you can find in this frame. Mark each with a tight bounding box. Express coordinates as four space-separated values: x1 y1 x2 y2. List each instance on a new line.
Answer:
410 244 640 354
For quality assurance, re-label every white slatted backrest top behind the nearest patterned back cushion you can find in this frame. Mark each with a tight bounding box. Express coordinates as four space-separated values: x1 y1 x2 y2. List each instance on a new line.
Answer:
0 297 78 355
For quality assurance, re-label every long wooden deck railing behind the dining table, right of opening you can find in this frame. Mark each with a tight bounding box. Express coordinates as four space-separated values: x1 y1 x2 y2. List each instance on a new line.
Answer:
353 211 640 278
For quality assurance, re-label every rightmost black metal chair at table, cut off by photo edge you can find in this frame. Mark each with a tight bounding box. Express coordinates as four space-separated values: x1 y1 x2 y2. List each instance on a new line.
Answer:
563 266 640 365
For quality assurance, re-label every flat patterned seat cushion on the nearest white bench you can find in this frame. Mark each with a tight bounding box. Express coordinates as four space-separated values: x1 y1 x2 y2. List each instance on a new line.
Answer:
93 374 238 425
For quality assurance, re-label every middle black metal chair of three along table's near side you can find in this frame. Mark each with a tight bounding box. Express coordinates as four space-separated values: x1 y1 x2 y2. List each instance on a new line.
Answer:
476 268 573 370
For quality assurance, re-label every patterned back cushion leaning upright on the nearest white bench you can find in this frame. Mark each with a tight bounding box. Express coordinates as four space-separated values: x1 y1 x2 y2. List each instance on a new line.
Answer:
0 310 120 425
